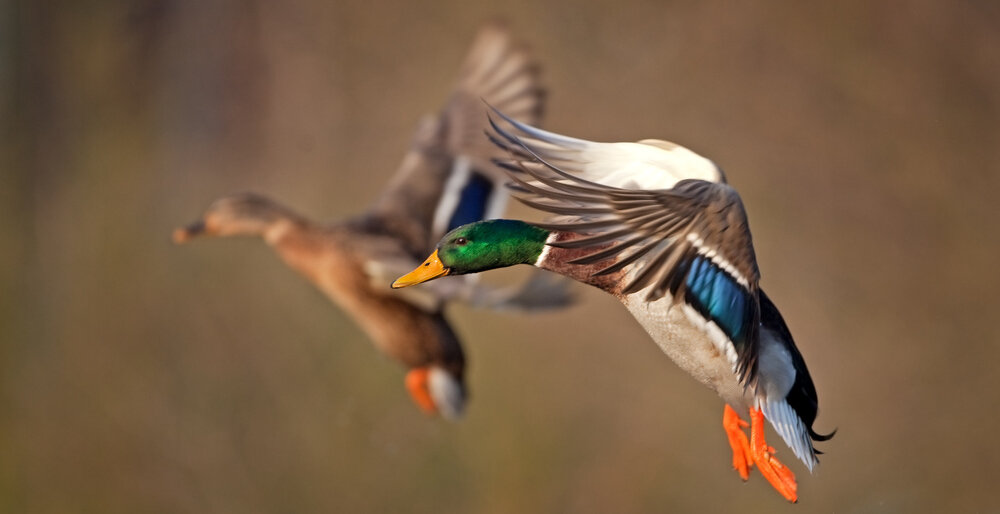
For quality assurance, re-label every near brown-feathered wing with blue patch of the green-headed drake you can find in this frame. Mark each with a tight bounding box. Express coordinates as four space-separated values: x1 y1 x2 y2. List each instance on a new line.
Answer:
491 112 760 384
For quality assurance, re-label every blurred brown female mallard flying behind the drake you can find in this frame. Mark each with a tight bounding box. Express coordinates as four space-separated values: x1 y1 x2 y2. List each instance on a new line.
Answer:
174 24 567 418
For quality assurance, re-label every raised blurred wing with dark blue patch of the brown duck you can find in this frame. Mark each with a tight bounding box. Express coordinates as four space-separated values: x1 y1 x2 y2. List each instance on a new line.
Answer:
370 23 544 258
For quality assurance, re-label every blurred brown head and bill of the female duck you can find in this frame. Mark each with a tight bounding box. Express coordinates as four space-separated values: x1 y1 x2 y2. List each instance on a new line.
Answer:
174 193 301 244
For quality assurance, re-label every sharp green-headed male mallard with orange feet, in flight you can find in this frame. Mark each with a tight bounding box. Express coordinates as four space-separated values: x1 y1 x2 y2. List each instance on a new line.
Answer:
393 112 832 502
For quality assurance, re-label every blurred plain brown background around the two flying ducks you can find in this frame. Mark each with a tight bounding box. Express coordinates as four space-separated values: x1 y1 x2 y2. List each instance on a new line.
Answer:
0 0 1000 513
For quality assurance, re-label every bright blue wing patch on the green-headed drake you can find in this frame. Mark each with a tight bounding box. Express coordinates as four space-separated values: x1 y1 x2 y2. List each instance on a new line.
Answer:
685 256 750 342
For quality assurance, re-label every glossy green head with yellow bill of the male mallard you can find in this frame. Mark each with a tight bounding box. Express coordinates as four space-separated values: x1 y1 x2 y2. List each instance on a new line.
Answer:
392 220 549 288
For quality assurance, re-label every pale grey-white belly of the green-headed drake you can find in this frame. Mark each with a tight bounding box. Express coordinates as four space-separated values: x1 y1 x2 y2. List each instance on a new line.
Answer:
622 291 753 413
